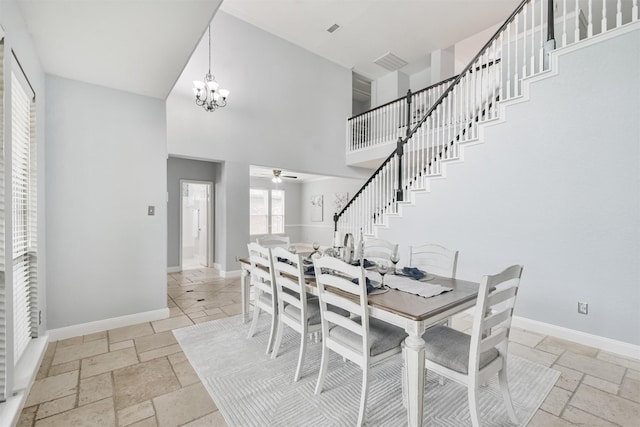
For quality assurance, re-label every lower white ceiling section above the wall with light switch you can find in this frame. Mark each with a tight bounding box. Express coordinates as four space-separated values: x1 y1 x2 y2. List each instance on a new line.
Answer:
18 0 222 99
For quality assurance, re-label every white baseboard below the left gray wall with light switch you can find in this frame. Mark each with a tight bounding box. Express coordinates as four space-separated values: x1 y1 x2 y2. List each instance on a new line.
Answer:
47 307 169 341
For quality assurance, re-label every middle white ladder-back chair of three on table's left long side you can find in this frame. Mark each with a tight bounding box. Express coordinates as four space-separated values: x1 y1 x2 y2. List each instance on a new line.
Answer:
271 248 321 381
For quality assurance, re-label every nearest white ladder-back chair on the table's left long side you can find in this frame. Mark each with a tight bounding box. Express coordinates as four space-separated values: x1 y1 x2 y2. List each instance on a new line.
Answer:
314 256 407 426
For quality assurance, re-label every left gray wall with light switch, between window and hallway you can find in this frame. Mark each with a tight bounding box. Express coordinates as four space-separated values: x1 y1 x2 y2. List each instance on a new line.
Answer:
46 76 167 329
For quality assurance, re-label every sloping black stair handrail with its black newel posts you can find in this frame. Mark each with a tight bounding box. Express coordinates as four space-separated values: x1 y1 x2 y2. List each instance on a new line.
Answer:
333 0 554 231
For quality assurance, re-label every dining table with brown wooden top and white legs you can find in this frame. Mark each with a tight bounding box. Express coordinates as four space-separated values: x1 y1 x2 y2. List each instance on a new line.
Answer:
240 258 480 427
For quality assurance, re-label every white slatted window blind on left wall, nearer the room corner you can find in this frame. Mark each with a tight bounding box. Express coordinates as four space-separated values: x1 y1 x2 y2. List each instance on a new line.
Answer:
11 67 37 363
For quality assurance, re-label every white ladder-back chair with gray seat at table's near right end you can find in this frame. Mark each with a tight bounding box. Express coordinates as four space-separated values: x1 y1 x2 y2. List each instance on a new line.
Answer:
422 265 522 427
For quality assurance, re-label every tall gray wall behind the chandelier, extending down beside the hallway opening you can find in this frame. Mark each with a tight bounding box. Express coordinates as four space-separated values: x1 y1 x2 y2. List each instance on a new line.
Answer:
167 12 366 271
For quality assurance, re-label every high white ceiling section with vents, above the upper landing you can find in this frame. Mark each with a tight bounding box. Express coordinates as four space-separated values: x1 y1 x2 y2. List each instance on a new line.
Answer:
220 0 520 79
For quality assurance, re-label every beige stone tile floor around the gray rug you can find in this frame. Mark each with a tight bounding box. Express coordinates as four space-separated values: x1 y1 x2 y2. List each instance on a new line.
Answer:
18 269 640 427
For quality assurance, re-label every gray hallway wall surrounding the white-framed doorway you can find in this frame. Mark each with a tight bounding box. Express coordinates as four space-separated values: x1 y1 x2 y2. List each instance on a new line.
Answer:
167 157 218 267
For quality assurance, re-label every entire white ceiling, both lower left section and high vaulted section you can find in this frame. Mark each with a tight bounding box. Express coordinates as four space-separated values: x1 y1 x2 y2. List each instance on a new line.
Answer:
18 0 518 99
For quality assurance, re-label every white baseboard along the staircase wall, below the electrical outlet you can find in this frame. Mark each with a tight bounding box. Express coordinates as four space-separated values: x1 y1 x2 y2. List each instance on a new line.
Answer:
512 316 640 359
